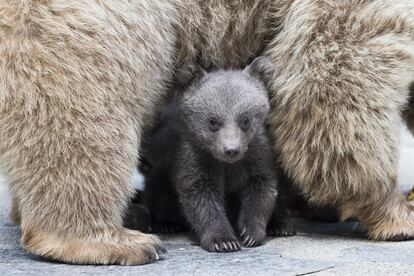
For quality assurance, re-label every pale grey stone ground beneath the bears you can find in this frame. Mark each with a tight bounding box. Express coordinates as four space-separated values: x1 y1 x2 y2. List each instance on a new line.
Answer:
0 130 414 275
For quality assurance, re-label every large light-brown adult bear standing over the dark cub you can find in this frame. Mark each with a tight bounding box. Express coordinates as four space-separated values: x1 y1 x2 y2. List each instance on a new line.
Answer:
0 0 414 264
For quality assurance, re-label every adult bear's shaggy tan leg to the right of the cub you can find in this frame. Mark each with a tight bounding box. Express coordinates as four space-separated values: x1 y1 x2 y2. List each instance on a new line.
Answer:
268 0 414 240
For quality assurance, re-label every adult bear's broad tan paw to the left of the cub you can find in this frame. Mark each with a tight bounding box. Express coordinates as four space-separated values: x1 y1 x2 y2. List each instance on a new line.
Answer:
22 226 166 265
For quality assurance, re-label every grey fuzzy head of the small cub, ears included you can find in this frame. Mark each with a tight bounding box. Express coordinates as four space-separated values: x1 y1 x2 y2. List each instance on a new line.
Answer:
178 57 274 163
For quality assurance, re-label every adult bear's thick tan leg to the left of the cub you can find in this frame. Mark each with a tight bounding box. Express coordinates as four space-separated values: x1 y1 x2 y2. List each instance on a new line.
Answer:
0 0 174 264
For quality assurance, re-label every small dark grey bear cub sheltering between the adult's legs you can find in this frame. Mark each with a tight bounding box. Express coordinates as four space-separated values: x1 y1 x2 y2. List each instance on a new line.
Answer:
126 57 295 252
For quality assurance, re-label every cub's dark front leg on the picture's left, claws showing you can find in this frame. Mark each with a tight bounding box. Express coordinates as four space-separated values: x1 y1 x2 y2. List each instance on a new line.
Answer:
175 151 241 252
